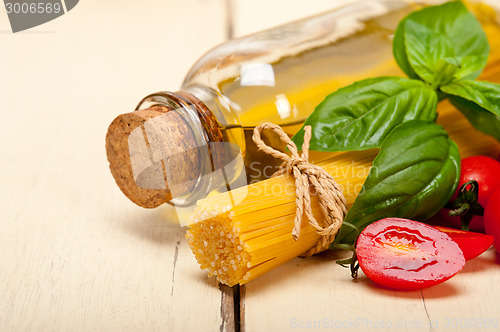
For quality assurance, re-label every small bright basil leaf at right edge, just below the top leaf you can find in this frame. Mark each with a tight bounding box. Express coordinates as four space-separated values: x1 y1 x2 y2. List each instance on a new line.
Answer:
441 80 500 115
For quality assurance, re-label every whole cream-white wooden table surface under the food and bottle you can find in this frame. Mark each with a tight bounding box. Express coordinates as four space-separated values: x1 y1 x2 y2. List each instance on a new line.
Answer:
0 0 500 331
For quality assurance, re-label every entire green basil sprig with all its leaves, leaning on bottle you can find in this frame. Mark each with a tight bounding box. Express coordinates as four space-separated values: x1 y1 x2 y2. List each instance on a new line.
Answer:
293 1 500 245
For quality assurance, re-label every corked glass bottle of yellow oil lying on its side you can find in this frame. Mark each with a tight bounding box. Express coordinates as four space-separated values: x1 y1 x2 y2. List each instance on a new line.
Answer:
106 0 500 208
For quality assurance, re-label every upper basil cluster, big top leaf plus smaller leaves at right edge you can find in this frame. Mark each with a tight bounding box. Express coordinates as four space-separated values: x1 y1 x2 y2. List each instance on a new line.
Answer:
393 1 500 140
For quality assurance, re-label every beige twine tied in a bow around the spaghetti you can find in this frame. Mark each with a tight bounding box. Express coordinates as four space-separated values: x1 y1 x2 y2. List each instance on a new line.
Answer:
252 123 347 256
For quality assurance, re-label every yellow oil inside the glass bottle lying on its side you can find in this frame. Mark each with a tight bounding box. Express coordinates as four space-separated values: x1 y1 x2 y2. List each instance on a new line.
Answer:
219 3 500 182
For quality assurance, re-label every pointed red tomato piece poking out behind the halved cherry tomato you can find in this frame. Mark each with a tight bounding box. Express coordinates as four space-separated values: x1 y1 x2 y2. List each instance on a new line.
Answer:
435 226 493 261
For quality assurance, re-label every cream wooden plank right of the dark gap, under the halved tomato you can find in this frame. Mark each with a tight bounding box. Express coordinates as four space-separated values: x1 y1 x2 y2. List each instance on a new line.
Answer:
242 249 500 332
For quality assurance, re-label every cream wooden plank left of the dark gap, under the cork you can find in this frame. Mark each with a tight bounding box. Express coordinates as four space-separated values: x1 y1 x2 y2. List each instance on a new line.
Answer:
0 0 234 331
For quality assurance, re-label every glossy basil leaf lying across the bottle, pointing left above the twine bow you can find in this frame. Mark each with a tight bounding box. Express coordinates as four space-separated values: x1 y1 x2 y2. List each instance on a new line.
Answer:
293 77 437 151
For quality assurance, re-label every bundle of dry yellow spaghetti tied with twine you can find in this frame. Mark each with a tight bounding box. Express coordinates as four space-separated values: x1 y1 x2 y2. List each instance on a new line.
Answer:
186 151 375 286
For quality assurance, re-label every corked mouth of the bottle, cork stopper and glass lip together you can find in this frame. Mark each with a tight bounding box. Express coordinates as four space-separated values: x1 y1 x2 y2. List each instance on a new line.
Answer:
106 92 229 208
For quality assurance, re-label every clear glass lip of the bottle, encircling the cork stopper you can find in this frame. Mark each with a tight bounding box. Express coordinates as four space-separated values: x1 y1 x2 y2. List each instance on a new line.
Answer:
136 91 224 207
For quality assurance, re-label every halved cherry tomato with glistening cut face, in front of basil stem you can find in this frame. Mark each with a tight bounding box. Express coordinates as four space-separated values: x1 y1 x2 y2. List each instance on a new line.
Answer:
356 218 465 290
